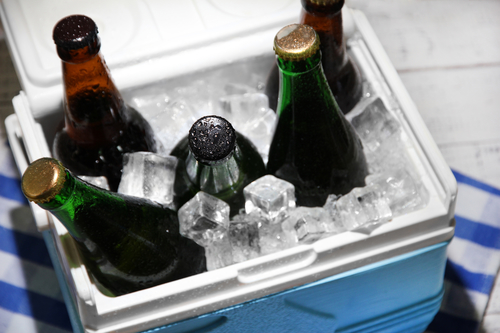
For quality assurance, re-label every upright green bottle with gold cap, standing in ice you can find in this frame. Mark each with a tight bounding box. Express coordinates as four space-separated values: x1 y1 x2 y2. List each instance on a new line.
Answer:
267 24 368 207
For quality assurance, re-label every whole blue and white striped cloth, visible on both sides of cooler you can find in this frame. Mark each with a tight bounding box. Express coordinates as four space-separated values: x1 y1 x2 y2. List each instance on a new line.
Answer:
0 133 500 333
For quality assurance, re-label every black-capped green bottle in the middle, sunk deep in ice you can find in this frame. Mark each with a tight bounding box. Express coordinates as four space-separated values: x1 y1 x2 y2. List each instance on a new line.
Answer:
171 116 266 216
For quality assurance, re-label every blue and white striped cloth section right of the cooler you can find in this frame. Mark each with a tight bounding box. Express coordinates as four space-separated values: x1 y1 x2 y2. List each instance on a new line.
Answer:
428 172 500 333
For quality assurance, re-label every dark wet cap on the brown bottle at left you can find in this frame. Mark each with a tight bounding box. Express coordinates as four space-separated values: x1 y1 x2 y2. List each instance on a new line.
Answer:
52 15 98 50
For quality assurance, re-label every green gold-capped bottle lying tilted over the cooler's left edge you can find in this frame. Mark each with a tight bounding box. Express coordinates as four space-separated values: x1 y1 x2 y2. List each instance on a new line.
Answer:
22 158 206 296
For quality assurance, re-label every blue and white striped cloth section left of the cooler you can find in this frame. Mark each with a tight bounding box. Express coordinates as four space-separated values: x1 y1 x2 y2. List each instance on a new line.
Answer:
0 138 72 333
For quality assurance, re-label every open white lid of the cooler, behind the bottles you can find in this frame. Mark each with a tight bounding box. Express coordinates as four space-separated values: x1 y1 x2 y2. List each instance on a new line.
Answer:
0 0 301 113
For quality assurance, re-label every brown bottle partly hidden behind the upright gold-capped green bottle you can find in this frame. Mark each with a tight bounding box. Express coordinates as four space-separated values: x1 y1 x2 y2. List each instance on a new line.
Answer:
266 0 363 114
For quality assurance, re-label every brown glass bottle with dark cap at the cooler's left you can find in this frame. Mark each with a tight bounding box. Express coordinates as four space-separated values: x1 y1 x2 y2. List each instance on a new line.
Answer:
53 15 156 191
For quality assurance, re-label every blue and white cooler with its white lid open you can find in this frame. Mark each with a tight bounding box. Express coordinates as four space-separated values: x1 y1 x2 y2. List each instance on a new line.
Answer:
0 0 457 333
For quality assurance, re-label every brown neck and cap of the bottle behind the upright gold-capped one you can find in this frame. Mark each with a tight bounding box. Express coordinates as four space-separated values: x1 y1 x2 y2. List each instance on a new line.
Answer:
300 0 347 76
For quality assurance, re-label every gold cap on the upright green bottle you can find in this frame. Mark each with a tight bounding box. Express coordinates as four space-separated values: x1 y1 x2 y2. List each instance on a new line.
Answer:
274 24 319 61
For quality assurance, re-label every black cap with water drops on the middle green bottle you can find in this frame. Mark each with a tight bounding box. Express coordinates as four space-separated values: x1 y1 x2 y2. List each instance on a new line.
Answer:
189 116 236 161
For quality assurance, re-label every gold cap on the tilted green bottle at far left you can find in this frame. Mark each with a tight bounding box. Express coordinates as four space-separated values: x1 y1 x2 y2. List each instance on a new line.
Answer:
21 157 66 203
